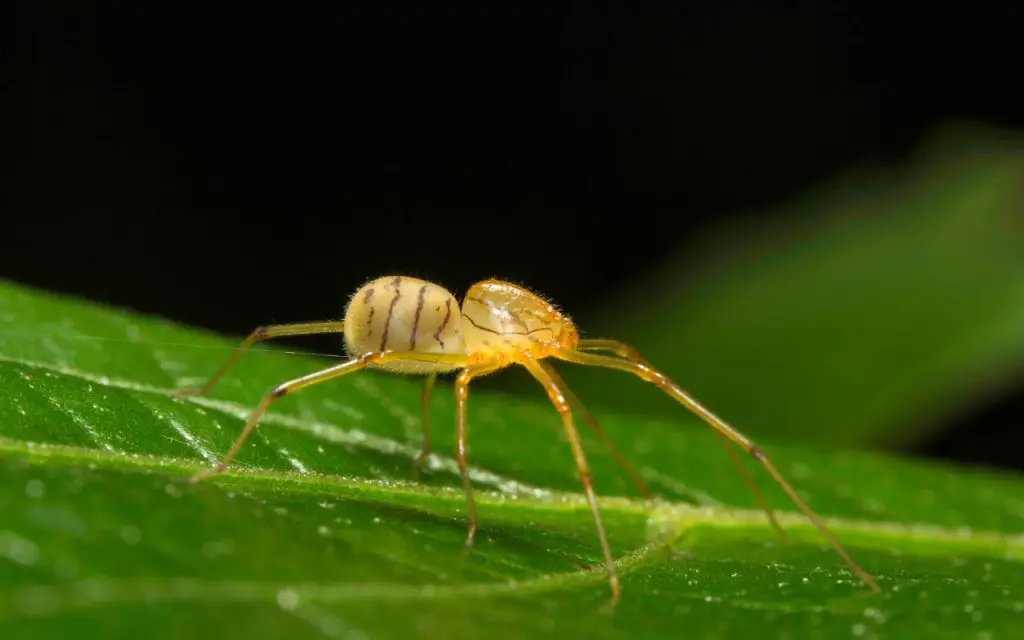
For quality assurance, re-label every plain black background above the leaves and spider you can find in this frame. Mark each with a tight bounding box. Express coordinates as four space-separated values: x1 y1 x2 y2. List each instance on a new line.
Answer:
8 0 1024 468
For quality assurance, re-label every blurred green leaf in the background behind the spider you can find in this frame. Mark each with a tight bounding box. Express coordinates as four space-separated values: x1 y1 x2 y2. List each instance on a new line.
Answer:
569 127 1024 447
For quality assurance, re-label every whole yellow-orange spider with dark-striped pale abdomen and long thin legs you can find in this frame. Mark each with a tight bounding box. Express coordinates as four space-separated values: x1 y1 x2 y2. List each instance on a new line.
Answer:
175 275 880 603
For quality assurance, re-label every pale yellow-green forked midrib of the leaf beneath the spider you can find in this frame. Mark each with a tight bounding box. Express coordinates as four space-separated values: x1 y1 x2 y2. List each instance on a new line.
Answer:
6 355 1024 569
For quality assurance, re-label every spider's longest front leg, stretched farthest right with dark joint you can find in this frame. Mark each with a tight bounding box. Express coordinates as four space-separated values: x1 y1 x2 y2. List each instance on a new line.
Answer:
555 350 880 591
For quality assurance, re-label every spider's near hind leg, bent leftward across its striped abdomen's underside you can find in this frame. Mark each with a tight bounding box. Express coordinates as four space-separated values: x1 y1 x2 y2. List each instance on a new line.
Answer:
190 351 469 482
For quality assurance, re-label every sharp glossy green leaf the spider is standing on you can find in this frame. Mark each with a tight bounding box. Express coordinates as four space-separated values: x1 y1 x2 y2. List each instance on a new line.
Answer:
0 284 1024 638
